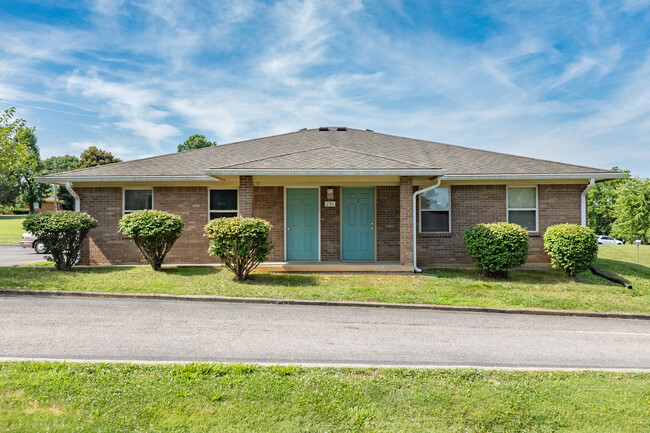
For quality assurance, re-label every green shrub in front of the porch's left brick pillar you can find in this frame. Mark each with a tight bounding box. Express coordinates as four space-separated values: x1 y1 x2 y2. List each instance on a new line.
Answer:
205 217 273 281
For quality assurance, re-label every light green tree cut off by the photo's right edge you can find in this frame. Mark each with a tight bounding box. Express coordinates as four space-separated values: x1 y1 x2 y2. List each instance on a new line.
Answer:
612 177 650 243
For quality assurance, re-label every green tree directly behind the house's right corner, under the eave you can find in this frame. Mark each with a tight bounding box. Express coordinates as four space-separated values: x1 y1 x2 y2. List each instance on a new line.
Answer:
587 167 630 235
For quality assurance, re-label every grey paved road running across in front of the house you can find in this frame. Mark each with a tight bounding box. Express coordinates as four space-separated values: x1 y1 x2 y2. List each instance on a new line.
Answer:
0 296 650 370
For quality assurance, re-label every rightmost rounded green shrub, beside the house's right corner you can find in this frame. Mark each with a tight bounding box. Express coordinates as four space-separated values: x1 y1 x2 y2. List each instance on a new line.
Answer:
544 224 598 275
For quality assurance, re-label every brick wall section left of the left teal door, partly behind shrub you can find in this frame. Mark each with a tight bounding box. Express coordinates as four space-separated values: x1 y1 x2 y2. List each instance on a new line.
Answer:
252 186 284 262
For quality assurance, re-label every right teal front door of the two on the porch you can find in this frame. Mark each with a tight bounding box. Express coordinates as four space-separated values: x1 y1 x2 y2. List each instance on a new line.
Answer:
341 188 375 260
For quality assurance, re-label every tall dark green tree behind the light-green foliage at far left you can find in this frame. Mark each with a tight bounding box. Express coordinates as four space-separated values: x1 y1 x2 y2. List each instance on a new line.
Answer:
13 127 52 213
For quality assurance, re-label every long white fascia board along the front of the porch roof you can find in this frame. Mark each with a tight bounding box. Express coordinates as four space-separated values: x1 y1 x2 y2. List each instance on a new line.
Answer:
203 168 445 176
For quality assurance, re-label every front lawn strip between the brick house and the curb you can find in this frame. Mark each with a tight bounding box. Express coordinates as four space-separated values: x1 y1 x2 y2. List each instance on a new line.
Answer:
0 251 650 313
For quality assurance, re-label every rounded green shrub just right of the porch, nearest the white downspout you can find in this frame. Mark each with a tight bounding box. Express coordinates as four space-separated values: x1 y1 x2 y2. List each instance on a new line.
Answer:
463 223 528 277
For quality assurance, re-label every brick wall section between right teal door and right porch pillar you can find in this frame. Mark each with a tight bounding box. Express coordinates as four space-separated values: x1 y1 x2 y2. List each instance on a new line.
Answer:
375 186 400 262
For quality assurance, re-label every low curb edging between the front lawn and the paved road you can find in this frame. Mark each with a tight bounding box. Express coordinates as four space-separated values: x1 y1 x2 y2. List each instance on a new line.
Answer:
0 288 650 320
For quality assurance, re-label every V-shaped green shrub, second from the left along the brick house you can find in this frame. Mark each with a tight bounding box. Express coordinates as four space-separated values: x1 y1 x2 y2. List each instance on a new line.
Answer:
118 210 184 271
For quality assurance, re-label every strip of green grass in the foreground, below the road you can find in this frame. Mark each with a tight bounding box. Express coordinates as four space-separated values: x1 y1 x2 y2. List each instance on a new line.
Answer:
0 362 650 432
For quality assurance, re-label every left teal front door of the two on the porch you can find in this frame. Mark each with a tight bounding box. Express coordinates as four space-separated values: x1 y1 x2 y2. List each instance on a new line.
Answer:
286 188 318 260
